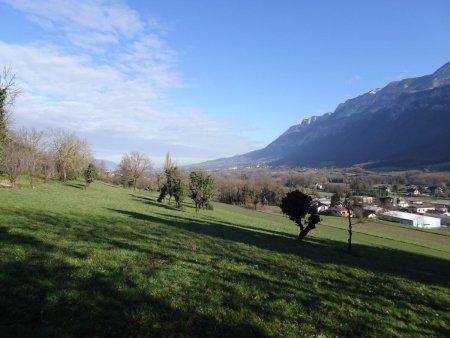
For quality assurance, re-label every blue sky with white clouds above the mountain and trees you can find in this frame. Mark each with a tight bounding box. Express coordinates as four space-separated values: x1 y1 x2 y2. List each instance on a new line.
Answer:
0 0 450 164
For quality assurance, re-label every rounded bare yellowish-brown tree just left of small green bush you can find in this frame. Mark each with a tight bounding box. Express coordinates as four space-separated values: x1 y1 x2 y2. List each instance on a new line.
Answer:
51 131 92 181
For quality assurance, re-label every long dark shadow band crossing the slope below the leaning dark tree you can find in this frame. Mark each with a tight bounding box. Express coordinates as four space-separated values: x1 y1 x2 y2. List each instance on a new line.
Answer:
110 209 450 287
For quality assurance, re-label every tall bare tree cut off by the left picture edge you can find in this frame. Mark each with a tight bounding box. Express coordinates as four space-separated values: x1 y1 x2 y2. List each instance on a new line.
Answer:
0 68 20 145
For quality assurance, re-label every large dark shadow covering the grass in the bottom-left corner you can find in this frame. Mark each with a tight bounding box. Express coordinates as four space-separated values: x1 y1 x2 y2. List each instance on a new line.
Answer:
0 228 267 337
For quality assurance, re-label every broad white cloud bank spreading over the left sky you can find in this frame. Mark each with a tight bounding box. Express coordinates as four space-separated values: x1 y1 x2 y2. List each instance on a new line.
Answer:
0 0 252 166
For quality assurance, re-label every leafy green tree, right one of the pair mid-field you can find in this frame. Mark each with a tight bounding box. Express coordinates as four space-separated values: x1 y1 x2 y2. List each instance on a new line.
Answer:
189 171 214 212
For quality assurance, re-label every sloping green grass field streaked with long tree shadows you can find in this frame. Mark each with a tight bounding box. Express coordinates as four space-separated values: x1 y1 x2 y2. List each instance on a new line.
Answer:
0 182 450 337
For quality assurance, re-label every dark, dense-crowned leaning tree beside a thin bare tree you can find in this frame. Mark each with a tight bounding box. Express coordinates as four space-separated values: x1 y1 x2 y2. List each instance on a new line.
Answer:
280 190 320 241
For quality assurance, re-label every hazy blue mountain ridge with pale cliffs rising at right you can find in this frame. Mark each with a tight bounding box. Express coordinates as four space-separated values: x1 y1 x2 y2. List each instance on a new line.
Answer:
199 63 450 168
